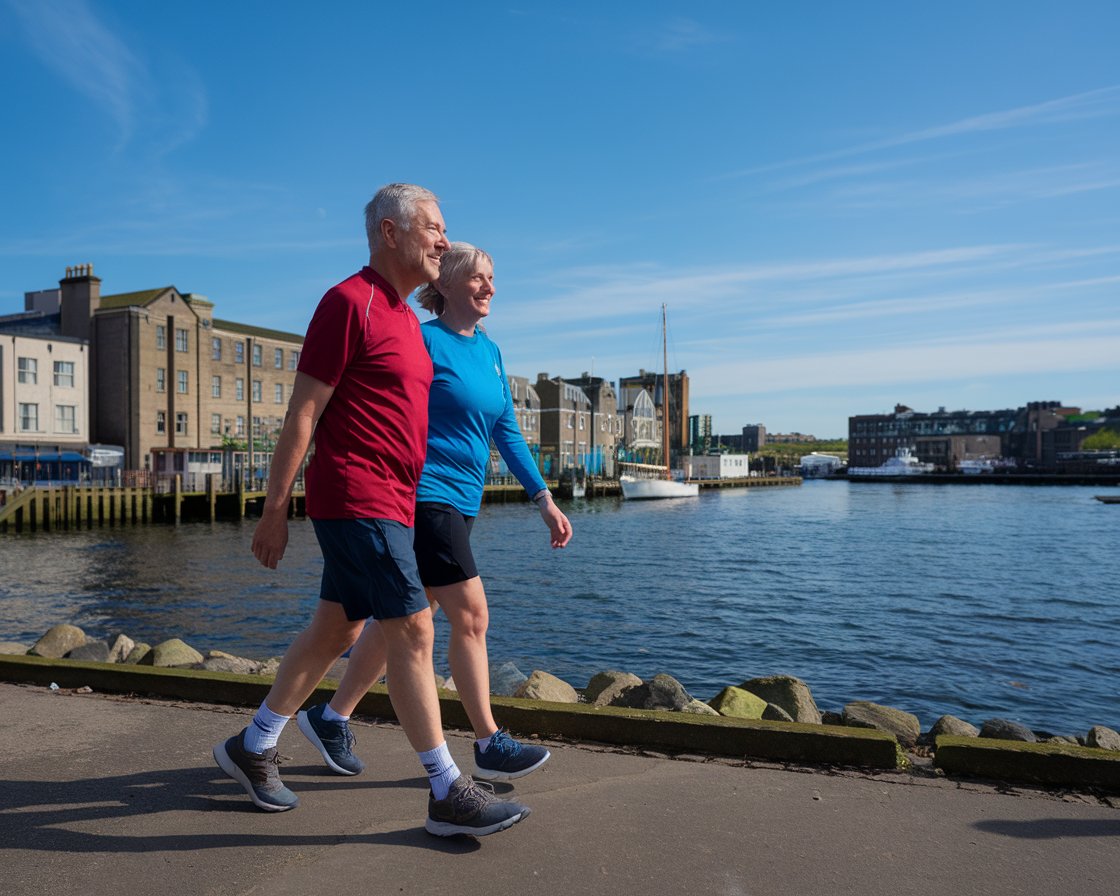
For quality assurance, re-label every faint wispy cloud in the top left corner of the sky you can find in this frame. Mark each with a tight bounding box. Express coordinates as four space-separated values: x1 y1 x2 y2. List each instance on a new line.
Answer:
4 0 208 155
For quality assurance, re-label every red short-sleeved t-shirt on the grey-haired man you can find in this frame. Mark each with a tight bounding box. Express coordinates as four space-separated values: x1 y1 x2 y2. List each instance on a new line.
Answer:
299 268 431 526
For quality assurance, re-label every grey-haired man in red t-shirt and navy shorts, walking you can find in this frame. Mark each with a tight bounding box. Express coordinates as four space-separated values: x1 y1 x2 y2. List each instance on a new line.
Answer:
214 184 529 836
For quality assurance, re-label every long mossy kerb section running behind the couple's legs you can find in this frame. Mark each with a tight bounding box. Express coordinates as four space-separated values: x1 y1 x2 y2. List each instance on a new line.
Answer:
0 655 900 769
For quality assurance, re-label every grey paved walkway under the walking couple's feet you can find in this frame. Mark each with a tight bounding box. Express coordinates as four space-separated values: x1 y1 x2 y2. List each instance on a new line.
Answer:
0 683 1120 896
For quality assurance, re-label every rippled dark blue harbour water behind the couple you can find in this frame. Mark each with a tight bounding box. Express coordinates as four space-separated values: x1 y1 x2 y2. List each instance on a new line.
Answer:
0 480 1120 734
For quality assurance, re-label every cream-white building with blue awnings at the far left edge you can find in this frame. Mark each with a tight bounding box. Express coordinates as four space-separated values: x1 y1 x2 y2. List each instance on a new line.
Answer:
0 329 90 482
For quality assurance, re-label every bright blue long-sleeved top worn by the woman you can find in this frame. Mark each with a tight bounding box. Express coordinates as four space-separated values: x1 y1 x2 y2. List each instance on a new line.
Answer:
417 319 545 516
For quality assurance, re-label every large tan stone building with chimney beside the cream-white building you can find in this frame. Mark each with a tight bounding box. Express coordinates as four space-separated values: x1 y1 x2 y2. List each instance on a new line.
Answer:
0 264 302 472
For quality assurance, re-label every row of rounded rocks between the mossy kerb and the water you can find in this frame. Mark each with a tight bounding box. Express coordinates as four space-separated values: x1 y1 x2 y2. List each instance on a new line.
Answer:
0 624 1120 752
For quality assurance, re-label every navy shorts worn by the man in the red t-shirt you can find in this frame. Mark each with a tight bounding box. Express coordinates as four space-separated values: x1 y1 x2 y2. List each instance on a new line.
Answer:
311 520 428 622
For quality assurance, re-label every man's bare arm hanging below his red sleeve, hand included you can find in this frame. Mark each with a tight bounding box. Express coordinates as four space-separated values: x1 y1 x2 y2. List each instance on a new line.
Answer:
253 372 335 569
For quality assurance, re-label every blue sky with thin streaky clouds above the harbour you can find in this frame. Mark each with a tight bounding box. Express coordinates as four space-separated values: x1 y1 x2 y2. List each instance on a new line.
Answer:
0 0 1120 437
